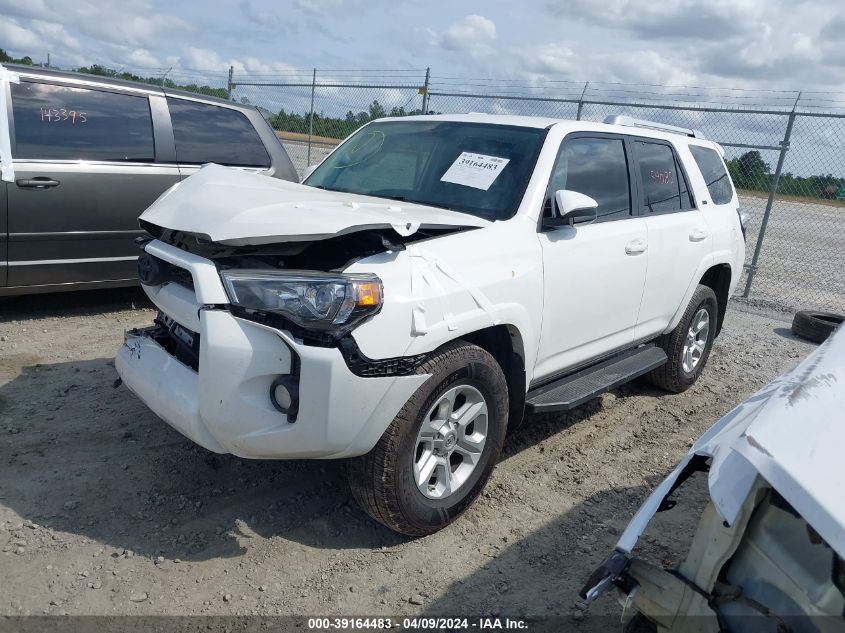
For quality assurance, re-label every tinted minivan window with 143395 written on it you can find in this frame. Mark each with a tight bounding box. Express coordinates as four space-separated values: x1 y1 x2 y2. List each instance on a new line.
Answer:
12 81 154 161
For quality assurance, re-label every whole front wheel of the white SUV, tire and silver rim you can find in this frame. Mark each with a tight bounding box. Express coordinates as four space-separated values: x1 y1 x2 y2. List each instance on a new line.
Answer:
347 341 508 536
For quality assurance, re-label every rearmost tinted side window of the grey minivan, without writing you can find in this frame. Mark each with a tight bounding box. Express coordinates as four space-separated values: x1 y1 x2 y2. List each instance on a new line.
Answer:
167 98 270 167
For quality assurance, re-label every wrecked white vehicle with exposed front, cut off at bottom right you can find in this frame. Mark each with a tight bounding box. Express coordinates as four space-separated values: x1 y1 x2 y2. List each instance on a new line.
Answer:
582 328 845 633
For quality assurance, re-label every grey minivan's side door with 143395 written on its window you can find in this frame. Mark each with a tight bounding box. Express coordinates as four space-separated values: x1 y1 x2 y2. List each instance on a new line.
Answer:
7 77 179 287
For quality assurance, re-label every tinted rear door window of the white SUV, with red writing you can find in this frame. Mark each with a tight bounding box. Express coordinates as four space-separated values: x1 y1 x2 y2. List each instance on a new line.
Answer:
637 141 691 214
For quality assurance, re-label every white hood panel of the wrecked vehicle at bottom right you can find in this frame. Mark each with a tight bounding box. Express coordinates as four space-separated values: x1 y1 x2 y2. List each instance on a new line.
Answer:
582 327 845 600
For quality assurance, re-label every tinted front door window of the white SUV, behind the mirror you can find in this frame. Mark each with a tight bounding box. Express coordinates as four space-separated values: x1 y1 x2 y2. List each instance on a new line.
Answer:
549 138 631 222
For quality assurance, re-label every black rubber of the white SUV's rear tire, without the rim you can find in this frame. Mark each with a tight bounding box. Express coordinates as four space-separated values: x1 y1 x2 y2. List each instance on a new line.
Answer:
647 284 719 393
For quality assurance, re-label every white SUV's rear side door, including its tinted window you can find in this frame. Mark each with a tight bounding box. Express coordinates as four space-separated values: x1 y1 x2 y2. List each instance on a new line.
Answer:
632 138 713 338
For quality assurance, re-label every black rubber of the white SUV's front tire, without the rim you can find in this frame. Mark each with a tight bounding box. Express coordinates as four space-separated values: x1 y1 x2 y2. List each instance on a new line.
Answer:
347 341 508 536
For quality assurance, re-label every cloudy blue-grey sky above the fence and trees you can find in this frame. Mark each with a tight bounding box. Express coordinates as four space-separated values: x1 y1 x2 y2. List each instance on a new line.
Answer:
0 0 845 174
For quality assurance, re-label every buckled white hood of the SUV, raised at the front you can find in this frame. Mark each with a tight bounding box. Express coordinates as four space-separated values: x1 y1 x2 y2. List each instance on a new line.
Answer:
141 165 491 246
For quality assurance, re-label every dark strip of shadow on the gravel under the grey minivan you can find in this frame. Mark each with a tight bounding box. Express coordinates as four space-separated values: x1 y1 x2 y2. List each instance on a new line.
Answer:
0 286 152 323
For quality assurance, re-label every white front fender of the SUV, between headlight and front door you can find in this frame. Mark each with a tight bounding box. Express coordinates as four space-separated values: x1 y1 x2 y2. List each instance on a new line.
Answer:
348 219 543 380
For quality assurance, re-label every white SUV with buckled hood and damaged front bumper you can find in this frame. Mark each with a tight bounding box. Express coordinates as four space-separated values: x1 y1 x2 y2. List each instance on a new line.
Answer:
116 114 745 535
